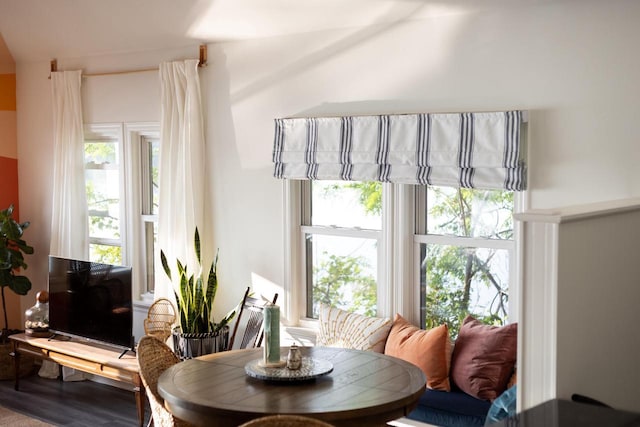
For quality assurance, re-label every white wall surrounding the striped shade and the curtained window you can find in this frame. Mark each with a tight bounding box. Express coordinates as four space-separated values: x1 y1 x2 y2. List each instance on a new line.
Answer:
17 0 640 409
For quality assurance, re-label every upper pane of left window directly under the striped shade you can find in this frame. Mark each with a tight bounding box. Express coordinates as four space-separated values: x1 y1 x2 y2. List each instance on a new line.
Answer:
311 181 382 230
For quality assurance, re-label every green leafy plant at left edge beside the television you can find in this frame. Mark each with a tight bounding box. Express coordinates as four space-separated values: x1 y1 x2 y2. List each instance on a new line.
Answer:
0 205 33 343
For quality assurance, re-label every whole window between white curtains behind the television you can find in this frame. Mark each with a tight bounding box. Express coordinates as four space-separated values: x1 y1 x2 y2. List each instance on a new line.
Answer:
84 124 160 296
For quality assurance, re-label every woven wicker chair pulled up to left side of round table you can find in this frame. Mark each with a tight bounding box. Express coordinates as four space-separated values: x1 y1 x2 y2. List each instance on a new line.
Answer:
136 335 191 427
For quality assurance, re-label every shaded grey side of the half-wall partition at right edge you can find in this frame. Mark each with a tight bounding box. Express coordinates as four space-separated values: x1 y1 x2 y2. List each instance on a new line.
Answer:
557 209 640 411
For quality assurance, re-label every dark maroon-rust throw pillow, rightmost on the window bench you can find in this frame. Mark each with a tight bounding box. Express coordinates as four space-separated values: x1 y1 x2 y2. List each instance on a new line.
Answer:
450 316 518 400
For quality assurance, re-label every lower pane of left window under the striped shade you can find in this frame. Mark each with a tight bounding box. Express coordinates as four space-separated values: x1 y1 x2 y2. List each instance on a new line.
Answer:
305 234 378 318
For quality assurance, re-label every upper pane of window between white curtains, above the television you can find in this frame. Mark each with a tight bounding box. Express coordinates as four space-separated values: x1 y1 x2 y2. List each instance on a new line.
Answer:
85 142 120 239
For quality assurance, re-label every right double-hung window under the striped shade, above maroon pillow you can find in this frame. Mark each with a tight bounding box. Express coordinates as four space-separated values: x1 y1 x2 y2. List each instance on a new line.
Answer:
415 187 515 336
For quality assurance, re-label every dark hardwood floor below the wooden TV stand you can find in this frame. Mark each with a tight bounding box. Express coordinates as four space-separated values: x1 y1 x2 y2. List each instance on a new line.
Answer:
0 373 151 427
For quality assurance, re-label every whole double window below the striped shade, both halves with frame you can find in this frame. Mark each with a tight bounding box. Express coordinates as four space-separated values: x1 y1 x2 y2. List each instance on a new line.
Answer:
288 180 517 336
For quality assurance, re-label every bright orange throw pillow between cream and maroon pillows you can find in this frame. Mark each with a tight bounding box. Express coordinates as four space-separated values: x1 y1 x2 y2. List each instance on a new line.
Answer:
384 314 451 391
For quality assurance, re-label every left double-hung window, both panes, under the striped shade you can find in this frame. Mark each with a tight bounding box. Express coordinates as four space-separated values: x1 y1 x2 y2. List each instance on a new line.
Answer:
301 181 382 318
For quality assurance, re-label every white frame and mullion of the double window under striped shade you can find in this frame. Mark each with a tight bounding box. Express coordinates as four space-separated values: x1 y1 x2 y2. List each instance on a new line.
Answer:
282 180 528 329
